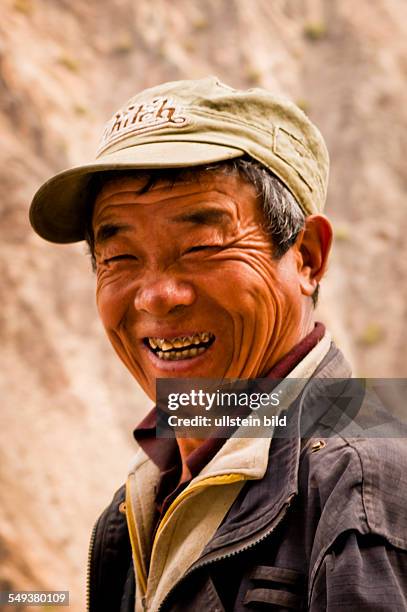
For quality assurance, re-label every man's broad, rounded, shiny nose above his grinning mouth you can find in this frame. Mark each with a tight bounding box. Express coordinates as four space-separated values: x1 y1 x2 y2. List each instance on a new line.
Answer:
134 276 196 317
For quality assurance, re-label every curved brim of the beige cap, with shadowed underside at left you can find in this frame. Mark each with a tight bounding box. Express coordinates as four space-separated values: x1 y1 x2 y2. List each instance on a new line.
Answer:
30 141 244 243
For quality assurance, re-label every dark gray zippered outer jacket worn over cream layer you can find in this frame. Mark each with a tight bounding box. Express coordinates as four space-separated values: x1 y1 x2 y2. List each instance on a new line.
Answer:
89 347 407 612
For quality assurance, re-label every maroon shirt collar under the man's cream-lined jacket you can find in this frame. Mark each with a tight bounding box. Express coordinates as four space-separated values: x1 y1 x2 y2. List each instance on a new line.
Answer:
134 323 325 524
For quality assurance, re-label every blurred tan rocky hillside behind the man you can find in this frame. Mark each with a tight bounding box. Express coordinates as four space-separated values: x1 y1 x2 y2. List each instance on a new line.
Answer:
0 0 407 612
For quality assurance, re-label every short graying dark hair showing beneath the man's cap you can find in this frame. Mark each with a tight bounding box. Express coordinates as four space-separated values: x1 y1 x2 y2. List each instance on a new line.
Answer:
85 157 319 306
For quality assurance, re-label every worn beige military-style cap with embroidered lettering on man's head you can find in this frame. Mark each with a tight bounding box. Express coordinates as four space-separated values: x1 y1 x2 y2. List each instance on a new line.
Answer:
30 77 329 243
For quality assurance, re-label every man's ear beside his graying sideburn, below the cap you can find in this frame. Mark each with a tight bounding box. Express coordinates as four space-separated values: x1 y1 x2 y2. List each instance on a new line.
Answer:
297 215 332 296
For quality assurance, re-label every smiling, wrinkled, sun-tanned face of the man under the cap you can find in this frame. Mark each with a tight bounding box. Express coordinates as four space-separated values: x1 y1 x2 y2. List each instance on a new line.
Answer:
93 173 310 398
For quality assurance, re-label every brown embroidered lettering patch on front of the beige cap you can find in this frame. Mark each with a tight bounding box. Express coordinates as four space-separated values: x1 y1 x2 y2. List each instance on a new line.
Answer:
97 96 190 155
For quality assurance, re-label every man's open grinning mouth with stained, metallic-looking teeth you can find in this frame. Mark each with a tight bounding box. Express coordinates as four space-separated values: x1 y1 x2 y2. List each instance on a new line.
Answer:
144 332 215 361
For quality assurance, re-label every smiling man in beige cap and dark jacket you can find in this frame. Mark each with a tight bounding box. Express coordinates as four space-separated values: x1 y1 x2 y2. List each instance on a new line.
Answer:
31 78 407 612
